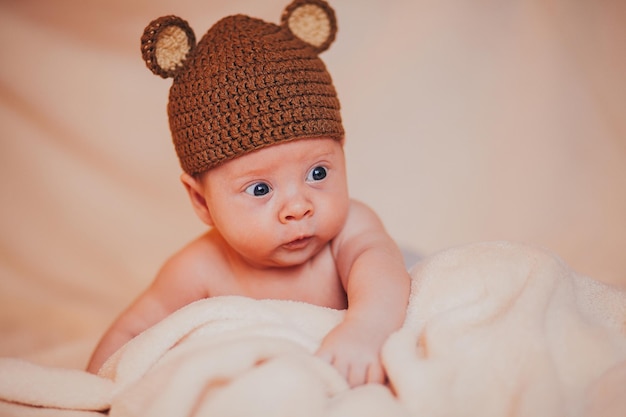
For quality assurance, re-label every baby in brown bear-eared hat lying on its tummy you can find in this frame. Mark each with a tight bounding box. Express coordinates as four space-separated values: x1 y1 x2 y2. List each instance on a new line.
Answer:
88 0 409 386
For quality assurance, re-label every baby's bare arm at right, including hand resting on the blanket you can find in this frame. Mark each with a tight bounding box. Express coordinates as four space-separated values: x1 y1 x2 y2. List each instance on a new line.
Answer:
318 202 410 386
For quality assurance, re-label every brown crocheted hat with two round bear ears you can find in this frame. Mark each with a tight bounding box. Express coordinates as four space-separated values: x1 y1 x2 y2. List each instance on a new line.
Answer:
141 0 344 175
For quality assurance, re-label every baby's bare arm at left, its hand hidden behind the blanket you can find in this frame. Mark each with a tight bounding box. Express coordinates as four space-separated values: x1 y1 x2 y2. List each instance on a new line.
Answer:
87 247 208 373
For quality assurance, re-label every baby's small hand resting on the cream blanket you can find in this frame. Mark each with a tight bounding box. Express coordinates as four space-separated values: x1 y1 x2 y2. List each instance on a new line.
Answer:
316 321 386 387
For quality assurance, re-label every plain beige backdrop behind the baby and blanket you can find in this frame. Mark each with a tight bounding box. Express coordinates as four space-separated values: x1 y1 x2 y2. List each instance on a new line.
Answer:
0 0 626 366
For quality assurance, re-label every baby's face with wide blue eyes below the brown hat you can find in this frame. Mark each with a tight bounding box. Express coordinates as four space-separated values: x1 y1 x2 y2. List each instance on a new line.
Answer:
203 139 350 267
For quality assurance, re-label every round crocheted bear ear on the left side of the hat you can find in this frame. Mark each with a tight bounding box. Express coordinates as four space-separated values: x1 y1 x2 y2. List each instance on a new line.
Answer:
141 16 196 78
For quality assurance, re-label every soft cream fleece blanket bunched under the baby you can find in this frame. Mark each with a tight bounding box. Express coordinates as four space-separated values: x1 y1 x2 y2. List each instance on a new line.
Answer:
0 242 626 417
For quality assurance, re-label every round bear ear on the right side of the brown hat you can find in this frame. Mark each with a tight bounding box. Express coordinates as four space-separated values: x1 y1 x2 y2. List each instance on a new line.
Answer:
281 0 337 53
